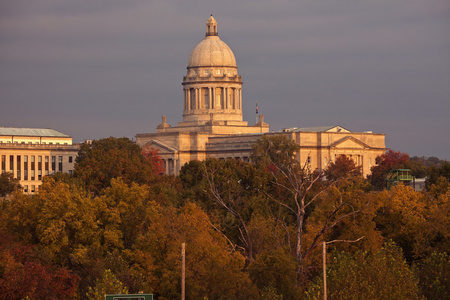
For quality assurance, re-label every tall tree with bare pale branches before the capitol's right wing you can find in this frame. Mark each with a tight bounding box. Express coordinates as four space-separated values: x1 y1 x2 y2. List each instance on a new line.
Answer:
252 136 369 285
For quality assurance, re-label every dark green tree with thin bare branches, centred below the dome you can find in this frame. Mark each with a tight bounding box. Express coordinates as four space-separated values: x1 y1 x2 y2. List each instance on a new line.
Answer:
180 159 268 261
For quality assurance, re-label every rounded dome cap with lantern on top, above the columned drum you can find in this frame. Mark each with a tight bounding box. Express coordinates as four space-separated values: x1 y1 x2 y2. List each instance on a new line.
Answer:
188 16 237 68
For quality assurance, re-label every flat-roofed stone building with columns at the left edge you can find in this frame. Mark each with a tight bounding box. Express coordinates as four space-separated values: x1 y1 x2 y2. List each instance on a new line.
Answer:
0 127 79 193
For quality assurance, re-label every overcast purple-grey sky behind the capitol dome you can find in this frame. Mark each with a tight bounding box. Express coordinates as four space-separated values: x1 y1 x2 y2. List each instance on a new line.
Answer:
0 0 450 160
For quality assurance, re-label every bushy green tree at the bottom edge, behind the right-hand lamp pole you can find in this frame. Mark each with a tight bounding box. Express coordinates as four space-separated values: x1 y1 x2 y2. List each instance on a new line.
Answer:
305 242 422 300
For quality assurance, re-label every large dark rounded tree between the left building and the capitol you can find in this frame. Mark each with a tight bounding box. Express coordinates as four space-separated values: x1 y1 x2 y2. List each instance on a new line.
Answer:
74 137 155 195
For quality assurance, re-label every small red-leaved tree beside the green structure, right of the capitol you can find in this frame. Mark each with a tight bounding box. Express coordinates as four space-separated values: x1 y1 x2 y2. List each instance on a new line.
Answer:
368 149 411 190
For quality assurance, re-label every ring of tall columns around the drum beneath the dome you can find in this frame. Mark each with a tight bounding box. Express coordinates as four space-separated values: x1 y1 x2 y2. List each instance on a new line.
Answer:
183 87 242 111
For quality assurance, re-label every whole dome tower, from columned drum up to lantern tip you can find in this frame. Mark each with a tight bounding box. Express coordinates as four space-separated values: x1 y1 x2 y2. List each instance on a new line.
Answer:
182 15 243 125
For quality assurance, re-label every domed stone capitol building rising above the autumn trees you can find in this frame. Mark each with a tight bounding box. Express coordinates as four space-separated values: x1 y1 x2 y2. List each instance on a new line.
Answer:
136 15 386 176
